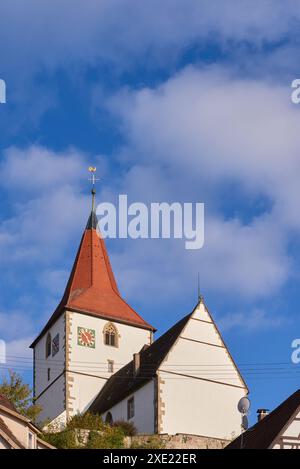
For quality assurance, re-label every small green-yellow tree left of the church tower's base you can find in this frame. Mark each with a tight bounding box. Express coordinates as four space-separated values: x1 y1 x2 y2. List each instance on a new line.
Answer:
0 370 42 420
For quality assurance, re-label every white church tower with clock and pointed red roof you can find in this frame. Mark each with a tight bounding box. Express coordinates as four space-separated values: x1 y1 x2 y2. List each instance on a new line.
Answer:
31 188 155 424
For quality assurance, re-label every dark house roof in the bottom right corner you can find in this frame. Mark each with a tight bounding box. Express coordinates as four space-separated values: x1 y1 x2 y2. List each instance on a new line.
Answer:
226 389 300 449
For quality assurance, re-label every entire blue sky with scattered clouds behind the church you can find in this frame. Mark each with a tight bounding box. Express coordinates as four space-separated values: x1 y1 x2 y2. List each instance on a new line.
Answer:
0 0 300 419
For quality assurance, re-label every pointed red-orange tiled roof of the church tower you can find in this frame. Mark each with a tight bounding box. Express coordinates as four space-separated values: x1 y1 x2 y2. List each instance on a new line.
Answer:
31 210 155 347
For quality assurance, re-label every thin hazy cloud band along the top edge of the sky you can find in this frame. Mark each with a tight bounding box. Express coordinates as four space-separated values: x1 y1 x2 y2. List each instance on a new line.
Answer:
0 0 300 71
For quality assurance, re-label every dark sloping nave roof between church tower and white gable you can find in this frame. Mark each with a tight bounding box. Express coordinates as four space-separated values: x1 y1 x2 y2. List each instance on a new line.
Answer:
89 313 192 414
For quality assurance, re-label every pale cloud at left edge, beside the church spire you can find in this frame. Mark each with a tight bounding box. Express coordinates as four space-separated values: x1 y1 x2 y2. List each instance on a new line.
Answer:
0 146 94 265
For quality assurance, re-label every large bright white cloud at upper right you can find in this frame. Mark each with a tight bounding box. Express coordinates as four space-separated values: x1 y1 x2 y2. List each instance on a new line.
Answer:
111 67 300 197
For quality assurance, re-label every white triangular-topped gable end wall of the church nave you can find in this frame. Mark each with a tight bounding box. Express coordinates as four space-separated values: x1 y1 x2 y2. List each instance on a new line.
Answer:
158 303 247 439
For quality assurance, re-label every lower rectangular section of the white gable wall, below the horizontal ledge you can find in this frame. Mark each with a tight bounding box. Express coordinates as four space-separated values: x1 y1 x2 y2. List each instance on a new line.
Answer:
159 372 245 440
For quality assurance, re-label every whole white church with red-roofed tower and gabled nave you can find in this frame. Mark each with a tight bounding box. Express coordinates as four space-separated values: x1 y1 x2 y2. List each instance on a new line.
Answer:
31 191 248 440
